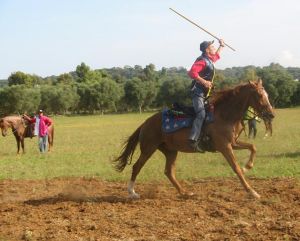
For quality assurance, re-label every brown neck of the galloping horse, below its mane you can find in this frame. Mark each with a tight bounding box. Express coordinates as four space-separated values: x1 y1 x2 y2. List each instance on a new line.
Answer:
219 89 250 123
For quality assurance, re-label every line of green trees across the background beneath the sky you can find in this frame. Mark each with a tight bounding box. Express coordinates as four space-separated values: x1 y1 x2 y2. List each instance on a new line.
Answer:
0 63 300 116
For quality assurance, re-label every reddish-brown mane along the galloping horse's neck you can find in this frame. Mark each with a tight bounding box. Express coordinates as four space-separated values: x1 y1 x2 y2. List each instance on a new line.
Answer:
210 83 249 106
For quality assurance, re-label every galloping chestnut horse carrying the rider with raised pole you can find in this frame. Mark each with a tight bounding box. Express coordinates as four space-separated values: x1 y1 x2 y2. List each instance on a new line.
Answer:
114 80 274 198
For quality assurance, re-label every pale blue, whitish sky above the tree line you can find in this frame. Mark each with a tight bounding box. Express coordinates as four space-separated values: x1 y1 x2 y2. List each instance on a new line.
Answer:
0 0 300 79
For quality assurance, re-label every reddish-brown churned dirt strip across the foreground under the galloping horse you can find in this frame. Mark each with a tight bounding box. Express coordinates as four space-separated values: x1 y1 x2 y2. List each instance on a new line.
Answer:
0 178 300 241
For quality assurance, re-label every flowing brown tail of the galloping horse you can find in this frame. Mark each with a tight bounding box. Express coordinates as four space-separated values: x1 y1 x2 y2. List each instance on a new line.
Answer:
113 126 142 172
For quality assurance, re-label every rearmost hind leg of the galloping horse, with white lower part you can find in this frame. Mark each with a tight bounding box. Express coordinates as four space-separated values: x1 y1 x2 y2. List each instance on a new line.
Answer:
128 147 157 198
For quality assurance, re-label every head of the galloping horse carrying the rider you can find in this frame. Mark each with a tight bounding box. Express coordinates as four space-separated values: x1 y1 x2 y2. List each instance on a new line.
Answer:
249 79 275 123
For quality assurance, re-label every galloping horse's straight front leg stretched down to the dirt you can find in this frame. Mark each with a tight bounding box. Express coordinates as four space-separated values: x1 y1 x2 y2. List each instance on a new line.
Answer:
220 143 260 198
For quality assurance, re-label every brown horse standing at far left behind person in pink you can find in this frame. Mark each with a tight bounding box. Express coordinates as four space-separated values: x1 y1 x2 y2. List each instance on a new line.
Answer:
0 116 54 154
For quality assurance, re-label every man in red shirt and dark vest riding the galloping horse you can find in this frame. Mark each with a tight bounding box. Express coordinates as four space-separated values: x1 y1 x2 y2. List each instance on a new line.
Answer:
189 39 225 152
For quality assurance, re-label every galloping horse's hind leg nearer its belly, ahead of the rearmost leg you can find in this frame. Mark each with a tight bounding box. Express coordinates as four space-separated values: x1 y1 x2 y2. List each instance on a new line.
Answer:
158 146 192 195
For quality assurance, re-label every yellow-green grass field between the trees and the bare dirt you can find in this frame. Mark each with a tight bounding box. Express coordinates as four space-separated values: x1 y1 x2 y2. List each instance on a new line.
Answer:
0 108 300 181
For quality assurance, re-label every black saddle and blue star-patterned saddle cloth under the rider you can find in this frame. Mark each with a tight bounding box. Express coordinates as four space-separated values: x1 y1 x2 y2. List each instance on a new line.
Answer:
162 102 216 152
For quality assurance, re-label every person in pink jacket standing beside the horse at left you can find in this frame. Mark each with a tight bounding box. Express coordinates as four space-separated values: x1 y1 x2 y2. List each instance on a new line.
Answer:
24 110 53 153
